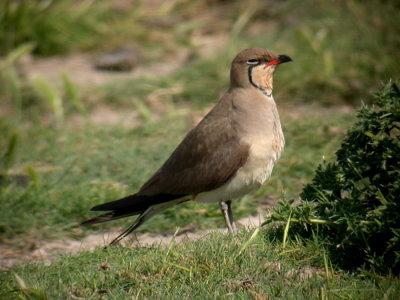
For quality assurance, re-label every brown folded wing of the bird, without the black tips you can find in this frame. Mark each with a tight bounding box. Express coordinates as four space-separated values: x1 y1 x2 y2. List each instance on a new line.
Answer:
138 96 249 195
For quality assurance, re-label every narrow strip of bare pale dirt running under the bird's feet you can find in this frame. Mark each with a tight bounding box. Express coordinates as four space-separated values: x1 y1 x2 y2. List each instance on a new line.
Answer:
0 214 264 269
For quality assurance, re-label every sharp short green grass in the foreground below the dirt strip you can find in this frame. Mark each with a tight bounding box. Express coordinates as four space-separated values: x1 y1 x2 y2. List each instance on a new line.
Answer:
0 231 400 299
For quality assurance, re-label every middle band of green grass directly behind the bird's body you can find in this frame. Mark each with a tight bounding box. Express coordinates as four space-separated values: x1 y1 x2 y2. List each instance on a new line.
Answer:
0 99 351 244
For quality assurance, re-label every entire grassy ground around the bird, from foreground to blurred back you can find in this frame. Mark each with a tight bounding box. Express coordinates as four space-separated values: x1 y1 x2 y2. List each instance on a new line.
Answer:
0 0 400 299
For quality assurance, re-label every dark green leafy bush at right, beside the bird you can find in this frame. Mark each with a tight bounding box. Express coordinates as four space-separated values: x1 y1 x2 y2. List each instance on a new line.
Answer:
267 82 400 273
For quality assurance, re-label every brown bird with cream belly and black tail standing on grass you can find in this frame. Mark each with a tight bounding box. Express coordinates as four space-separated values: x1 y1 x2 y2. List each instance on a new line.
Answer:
82 48 292 245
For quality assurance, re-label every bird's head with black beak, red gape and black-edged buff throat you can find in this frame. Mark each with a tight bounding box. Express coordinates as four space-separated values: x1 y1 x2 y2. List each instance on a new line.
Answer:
231 48 292 96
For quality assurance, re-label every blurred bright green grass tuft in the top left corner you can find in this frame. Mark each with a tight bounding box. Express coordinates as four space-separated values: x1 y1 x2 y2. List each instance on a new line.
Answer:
0 0 105 55
